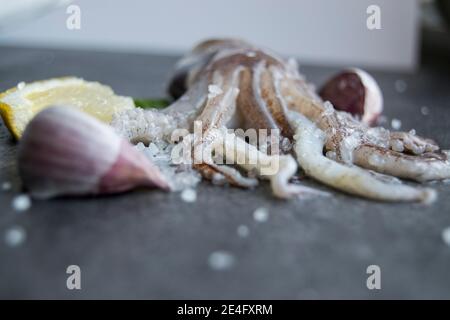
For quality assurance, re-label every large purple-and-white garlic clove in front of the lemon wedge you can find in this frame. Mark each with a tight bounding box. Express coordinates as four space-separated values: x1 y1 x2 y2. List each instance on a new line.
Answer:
18 106 169 199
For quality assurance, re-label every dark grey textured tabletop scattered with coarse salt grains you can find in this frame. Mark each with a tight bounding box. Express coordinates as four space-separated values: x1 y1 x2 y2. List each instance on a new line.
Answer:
0 47 450 298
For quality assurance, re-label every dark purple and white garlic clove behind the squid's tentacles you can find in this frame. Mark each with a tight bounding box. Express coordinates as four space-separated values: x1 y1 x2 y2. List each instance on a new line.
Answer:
319 68 383 125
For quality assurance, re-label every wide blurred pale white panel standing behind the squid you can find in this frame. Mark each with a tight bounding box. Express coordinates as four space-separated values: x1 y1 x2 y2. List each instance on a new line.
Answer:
0 0 420 69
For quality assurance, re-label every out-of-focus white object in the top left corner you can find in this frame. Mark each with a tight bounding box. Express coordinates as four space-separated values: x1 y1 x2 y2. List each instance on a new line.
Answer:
0 0 72 29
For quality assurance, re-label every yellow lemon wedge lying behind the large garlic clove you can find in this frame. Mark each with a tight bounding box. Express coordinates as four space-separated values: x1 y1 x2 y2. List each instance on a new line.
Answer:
0 77 135 139
